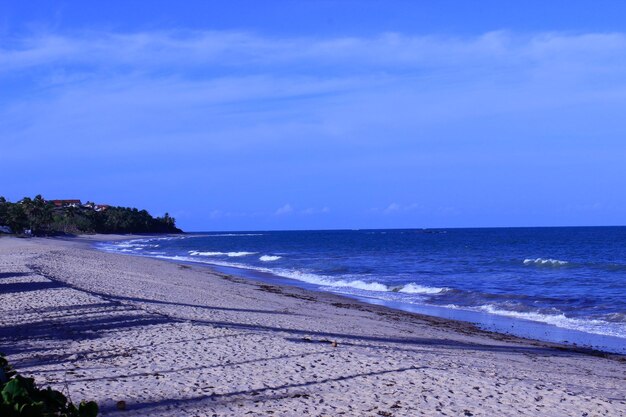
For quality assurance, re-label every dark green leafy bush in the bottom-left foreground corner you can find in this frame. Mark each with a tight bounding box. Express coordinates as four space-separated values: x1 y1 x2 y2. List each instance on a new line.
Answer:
0 353 98 417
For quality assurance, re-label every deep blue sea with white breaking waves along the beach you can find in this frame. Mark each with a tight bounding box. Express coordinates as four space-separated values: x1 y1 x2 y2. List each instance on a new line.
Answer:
100 227 626 353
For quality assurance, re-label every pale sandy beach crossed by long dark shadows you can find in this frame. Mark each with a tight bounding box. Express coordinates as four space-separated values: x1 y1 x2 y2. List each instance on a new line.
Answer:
0 236 626 417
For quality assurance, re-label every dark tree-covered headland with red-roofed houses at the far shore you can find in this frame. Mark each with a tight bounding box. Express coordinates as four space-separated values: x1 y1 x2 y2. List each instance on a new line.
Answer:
0 195 181 235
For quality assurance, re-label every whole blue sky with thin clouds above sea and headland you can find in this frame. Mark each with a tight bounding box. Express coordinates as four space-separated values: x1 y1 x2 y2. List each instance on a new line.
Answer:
0 1 626 231
